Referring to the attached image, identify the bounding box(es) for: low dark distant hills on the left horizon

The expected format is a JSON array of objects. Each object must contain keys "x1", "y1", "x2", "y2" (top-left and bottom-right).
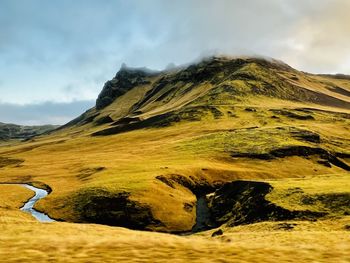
[{"x1": 0, "y1": 122, "x2": 58, "y2": 141}]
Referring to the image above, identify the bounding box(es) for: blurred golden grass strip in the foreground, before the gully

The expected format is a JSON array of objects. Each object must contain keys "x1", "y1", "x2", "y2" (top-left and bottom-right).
[{"x1": 0, "y1": 185, "x2": 350, "y2": 263}]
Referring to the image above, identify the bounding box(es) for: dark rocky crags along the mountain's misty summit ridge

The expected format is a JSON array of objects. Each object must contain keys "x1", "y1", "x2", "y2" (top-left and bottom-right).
[{"x1": 96, "y1": 57, "x2": 293, "y2": 110}]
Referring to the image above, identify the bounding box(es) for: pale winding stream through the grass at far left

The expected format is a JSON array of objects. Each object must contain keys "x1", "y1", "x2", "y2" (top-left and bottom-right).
[{"x1": 21, "y1": 184, "x2": 55, "y2": 222}]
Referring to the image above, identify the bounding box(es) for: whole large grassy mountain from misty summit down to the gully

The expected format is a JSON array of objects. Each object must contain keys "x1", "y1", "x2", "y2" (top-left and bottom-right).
[{"x1": 0, "y1": 56, "x2": 350, "y2": 233}]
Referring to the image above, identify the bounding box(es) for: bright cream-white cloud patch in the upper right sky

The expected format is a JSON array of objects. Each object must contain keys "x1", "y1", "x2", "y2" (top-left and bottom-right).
[{"x1": 280, "y1": 0, "x2": 350, "y2": 74}]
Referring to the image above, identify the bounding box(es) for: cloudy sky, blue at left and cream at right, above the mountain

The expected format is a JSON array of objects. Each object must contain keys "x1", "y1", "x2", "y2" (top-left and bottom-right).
[{"x1": 0, "y1": 0, "x2": 350, "y2": 125}]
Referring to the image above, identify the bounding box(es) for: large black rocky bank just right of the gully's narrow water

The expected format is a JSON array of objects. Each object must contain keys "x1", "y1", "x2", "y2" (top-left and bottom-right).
[{"x1": 209, "y1": 181, "x2": 325, "y2": 226}]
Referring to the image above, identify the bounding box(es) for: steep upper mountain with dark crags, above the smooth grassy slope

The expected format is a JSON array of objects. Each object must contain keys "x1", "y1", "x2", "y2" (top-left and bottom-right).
[{"x1": 64, "y1": 57, "x2": 350, "y2": 135}]
